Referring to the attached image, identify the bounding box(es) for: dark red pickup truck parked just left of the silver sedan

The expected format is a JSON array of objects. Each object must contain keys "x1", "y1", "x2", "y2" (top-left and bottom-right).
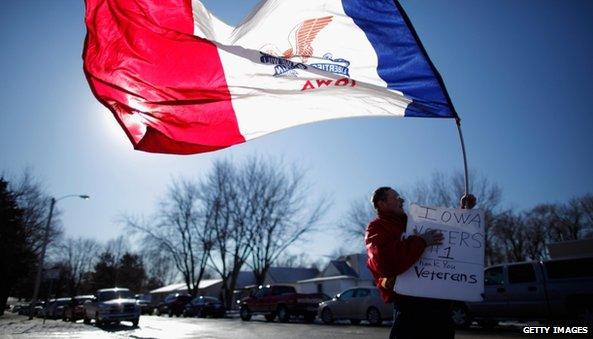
[{"x1": 239, "y1": 285, "x2": 325, "y2": 322}]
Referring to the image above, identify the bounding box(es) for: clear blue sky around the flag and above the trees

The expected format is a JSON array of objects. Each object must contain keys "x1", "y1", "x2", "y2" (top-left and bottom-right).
[{"x1": 0, "y1": 0, "x2": 593, "y2": 258}]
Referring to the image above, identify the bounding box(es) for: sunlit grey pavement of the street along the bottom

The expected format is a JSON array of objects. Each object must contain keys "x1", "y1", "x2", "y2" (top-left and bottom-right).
[{"x1": 0, "y1": 313, "x2": 582, "y2": 339}]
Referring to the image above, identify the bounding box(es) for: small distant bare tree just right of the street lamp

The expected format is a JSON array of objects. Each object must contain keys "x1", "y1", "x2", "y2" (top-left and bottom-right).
[{"x1": 59, "y1": 238, "x2": 101, "y2": 295}]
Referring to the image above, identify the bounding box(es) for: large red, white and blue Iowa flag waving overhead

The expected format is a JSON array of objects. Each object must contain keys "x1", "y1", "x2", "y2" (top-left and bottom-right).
[{"x1": 83, "y1": 0, "x2": 457, "y2": 154}]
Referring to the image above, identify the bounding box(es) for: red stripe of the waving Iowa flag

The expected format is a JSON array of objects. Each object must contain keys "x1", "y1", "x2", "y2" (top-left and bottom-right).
[{"x1": 83, "y1": 0, "x2": 245, "y2": 154}]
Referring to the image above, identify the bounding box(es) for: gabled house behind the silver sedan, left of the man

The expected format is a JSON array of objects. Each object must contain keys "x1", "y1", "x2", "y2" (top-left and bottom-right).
[{"x1": 297, "y1": 253, "x2": 373, "y2": 296}]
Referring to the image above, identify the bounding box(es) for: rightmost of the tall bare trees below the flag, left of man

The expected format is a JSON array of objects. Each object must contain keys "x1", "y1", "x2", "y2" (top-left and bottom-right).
[{"x1": 242, "y1": 158, "x2": 329, "y2": 284}]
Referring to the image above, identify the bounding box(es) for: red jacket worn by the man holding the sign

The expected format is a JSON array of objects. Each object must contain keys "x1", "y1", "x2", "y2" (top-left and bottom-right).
[{"x1": 364, "y1": 213, "x2": 426, "y2": 303}]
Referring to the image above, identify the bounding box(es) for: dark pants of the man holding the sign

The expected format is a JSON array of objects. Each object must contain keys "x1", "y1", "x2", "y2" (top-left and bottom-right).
[{"x1": 389, "y1": 297, "x2": 455, "y2": 339}]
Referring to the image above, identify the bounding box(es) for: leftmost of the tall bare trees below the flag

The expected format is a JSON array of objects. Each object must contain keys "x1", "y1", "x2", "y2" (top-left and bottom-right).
[{"x1": 125, "y1": 180, "x2": 212, "y2": 295}]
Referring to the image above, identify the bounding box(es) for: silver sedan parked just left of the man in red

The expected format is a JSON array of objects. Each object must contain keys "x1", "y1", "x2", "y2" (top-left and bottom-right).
[{"x1": 318, "y1": 286, "x2": 393, "y2": 326}]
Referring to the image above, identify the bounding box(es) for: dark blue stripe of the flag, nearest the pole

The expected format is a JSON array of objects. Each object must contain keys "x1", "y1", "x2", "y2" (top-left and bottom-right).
[{"x1": 342, "y1": 0, "x2": 456, "y2": 118}]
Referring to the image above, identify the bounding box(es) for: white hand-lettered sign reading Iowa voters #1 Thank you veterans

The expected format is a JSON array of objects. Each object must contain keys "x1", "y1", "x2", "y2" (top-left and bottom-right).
[{"x1": 395, "y1": 204, "x2": 485, "y2": 301}]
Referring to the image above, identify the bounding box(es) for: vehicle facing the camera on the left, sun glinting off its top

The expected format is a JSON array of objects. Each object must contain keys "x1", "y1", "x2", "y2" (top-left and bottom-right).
[{"x1": 83, "y1": 287, "x2": 140, "y2": 327}]
